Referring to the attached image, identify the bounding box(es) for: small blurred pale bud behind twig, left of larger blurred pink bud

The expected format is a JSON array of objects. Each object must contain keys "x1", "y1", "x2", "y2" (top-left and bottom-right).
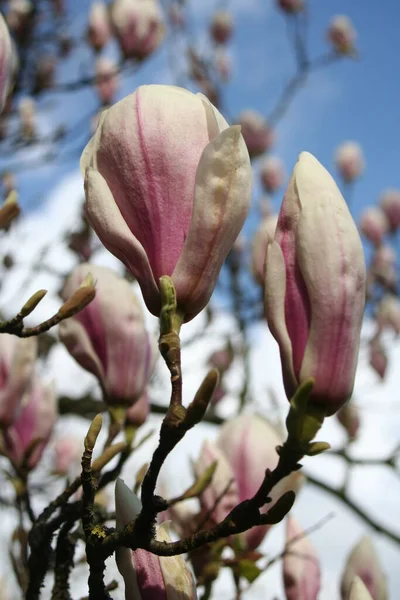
[{"x1": 194, "y1": 440, "x2": 239, "y2": 523}]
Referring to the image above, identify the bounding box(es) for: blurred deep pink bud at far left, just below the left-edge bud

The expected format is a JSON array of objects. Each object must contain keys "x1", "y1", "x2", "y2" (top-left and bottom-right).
[{"x1": 4, "y1": 375, "x2": 57, "y2": 469}]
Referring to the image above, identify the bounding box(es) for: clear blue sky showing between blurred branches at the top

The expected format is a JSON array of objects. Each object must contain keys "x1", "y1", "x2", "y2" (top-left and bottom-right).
[{"x1": 2, "y1": 0, "x2": 400, "y2": 239}]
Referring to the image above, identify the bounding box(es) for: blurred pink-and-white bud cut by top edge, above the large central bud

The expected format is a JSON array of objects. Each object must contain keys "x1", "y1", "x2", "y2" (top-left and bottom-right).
[{"x1": 110, "y1": 0, "x2": 164, "y2": 60}]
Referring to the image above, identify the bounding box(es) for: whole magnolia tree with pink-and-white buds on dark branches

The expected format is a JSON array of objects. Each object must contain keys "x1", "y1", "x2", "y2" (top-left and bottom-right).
[{"x1": 0, "y1": 0, "x2": 400, "y2": 600}]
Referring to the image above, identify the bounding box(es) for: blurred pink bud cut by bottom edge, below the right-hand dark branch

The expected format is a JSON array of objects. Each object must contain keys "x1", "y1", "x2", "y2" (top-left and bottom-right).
[{"x1": 283, "y1": 517, "x2": 321, "y2": 600}]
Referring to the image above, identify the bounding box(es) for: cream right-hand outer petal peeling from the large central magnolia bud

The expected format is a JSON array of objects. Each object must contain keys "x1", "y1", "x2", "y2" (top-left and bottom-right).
[{"x1": 172, "y1": 126, "x2": 251, "y2": 321}]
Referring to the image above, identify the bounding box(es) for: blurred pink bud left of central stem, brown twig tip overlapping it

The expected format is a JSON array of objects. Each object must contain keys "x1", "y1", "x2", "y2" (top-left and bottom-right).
[{"x1": 60, "y1": 263, "x2": 156, "y2": 406}]
